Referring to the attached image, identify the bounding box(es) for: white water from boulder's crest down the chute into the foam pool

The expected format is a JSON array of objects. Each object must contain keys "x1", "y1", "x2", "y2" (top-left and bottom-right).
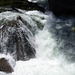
[{"x1": 0, "y1": 11, "x2": 75, "y2": 75}]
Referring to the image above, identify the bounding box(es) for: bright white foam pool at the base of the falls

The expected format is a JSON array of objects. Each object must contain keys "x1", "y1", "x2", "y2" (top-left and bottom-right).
[{"x1": 12, "y1": 59, "x2": 75, "y2": 75}]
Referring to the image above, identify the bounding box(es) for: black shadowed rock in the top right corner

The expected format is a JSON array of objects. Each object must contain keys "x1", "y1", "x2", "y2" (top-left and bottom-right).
[{"x1": 48, "y1": 0, "x2": 75, "y2": 16}]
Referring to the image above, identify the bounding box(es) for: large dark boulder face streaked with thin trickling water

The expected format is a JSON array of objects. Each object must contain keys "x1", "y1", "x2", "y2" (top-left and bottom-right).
[{"x1": 0, "y1": 16, "x2": 35, "y2": 60}]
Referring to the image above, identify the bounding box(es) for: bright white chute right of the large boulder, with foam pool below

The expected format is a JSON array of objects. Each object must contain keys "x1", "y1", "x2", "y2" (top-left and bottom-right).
[{"x1": 12, "y1": 11, "x2": 75, "y2": 75}]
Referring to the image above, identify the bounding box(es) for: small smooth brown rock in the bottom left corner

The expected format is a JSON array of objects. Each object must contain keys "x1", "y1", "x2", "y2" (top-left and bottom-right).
[{"x1": 0, "y1": 58, "x2": 14, "y2": 73}]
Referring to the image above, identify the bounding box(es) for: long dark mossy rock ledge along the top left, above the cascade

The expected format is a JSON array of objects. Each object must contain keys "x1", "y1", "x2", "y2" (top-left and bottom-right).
[{"x1": 0, "y1": 0, "x2": 45, "y2": 12}]
